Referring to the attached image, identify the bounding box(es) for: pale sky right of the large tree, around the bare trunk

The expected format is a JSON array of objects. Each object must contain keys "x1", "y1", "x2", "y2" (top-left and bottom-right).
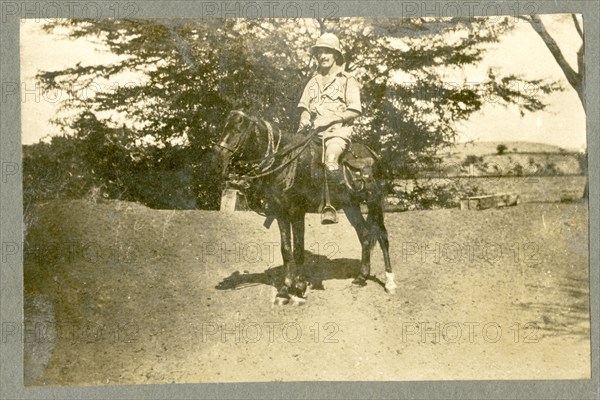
[{"x1": 459, "y1": 15, "x2": 587, "y2": 149}]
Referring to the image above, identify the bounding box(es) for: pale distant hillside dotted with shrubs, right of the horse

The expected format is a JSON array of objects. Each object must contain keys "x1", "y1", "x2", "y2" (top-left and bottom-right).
[{"x1": 438, "y1": 142, "x2": 583, "y2": 176}]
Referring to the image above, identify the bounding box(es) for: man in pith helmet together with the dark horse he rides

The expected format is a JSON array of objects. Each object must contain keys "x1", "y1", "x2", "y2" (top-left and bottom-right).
[{"x1": 216, "y1": 34, "x2": 397, "y2": 296}]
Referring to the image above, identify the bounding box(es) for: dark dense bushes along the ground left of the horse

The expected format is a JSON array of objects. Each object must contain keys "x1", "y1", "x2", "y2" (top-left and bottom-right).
[{"x1": 23, "y1": 114, "x2": 221, "y2": 209}]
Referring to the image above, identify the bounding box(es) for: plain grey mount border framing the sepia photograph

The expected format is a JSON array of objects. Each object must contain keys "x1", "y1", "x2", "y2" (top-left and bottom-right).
[{"x1": 0, "y1": 0, "x2": 600, "y2": 399}]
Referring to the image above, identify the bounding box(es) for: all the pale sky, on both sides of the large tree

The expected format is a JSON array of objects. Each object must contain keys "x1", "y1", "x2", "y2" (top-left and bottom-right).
[{"x1": 20, "y1": 15, "x2": 586, "y2": 150}]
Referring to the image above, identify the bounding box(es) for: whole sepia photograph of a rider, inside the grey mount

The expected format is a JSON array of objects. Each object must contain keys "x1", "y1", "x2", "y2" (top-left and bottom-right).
[{"x1": 18, "y1": 12, "x2": 592, "y2": 387}]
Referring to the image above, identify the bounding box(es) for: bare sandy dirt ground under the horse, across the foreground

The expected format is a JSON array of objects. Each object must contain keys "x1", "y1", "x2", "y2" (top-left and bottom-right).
[{"x1": 25, "y1": 201, "x2": 590, "y2": 385}]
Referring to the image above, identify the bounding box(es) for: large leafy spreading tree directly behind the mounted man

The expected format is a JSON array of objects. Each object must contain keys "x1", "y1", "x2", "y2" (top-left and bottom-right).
[{"x1": 39, "y1": 18, "x2": 559, "y2": 207}]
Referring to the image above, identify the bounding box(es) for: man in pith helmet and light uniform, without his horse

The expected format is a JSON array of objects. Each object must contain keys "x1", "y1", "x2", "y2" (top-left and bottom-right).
[{"x1": 298, "y1": 33, "x2": 362, "y2": 222}]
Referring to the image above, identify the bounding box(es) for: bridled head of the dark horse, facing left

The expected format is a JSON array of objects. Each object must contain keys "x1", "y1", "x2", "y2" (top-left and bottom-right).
[{"x1": 216, "y1": 110, "x2": 257, "y2": 178}]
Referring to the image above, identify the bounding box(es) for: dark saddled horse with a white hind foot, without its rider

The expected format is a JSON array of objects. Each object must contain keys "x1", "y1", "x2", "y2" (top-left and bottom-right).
[{"x1": 214, "y1": 110, "x2": 397, "y2": 304}]
